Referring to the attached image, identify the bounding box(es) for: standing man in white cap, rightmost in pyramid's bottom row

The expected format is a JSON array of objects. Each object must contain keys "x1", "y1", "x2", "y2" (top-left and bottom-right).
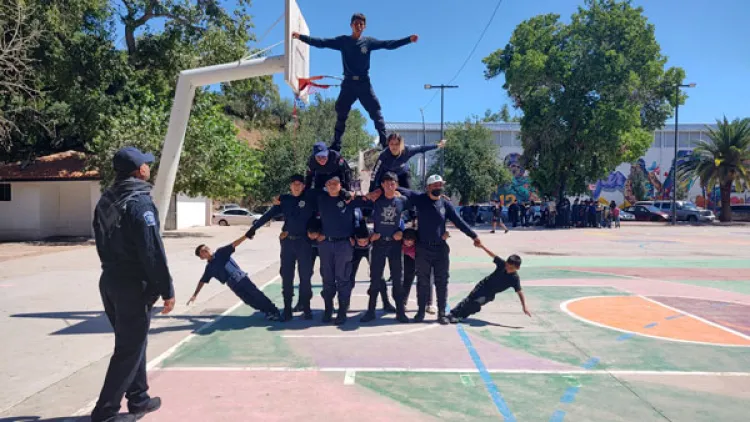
[{"x1": 369, "y1": 174, "x2": 482, "y2": 325}]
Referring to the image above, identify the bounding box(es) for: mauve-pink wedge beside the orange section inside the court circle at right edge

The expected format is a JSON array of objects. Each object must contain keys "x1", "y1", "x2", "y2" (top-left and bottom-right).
[{"x1": 651, "y1": 296, "x2": 750, "y2": 335}]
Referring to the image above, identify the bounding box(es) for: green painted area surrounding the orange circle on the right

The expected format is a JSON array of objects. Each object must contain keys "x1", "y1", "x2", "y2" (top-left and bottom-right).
[{"x1": 467, "y1": 287, "x2": 750, "y2": 372}]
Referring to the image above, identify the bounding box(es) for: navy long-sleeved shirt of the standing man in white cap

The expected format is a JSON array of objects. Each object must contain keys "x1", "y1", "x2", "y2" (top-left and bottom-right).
[{"x1": 398, "y1": 188, "x2": 477, "y2": 243}]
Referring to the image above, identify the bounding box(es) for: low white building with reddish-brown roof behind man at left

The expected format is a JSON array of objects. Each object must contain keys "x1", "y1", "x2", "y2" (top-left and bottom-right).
[{"x1": 0, "y1": 151, "x2": 211, "y2": 241}]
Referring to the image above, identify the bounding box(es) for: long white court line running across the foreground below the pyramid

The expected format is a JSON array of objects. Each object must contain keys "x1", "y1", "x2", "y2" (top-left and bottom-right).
[{"x1": 157, "y1": 366, "x2": 750, "y2": 377}]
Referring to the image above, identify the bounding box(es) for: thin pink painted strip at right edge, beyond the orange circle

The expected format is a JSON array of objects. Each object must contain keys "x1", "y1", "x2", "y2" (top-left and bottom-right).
[{"x1": 564, "y1": 267, "x2": 750, "y2": 281}]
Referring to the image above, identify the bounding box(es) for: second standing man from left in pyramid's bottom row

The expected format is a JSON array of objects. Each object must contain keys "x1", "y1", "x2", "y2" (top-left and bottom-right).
[{"x1": 317, "y1": 177, "x2": 365, "y2": 325}]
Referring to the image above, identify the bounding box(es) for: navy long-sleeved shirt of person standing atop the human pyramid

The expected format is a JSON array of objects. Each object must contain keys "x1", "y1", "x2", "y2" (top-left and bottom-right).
[{"x1": 299, "y1": 34, "x2": 411, "y2": 76}]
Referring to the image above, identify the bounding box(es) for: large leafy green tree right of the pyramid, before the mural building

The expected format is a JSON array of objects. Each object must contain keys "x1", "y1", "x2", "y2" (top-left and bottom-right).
[{"x1": 483, "y1": 0, "x2": 686, "y2": 197}]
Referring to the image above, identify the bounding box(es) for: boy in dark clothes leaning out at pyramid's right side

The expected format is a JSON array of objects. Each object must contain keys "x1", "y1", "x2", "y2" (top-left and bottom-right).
[{"x1": 448, "y1": 245, "x2": 531, "y2": 324}]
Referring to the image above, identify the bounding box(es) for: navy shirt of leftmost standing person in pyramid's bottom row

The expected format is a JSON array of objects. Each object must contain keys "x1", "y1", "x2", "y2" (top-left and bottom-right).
[{"x1": 248, "y1": 190, "x2": 318, "y2": 238}]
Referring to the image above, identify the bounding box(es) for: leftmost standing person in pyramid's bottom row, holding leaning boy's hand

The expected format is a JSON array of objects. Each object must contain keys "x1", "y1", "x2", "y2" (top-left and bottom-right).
[{"x1": 247, "y1": 174, "x2": 317, "y2": 321}]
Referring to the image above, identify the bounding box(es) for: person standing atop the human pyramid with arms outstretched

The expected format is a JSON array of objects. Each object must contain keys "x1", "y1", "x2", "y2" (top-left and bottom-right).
[{"x1": 292, "y1": 13, "x2": 418, "y2": 151}]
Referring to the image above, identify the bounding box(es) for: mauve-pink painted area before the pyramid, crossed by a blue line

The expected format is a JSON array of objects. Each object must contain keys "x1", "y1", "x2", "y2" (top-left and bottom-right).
[{"x1": 286, "y1": 324, "x2": 568, "y2": 370}]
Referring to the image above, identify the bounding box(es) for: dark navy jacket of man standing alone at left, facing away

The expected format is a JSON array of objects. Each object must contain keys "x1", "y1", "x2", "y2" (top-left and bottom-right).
[{"x1": 93, "y1": 178, "x2": 174, "y2": 301}]
